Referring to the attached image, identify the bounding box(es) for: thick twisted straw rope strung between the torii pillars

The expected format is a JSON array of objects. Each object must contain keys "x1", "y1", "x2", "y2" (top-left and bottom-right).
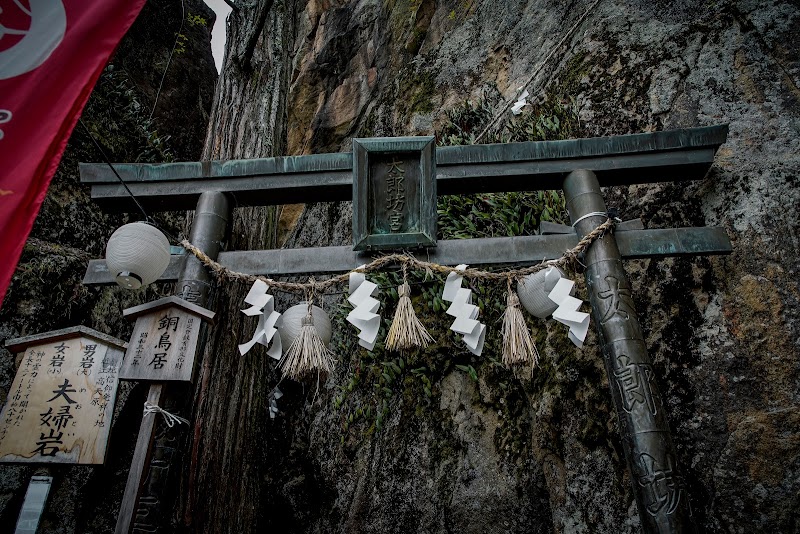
[{"x1": 181, "y1": 218, "x2": 615, "y2": 294}]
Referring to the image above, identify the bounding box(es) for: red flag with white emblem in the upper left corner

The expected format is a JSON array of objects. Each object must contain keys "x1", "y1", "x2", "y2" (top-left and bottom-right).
[{"x1": 0, "y1": 0, "x2": 145, "y2": 305}]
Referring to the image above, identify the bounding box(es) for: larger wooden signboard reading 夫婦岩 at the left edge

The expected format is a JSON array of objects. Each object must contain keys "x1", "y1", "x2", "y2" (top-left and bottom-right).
[{"x1": 0, "y1": 326, "x2": 126, "y2": 464}]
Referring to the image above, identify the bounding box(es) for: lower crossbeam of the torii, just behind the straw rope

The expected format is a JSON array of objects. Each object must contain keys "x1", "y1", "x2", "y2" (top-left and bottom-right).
[{"x1": 83, "y1": 223, "x2": 733, "y2": 285}]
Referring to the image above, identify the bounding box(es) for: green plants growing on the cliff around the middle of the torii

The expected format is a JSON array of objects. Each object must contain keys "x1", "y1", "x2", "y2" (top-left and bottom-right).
[{"x1": 332, "y1": 86, "x2": 596, "y2": 458}]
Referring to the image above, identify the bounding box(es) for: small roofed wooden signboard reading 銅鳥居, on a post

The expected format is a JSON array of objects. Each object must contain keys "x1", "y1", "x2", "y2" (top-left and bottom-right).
[{"x1": 119, "y1": 297, "x2": 214, "y2": 382}]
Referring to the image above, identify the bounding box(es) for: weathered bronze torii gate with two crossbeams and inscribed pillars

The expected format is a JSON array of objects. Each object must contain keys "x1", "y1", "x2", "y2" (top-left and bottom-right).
[{"x1": 80, "y1": 126, "x2": 731, "y2": 533}]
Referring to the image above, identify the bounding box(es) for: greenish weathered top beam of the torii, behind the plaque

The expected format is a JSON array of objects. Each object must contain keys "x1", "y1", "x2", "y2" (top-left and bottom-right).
[{"x1": 80, "y1": 125, "x2": 728, "y2": 211}]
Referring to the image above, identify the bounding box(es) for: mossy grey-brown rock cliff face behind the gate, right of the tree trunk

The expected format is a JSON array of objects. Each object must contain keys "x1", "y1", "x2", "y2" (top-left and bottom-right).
[{"x1": 202, "y1": 0, "x2": 800, "y2": 533}]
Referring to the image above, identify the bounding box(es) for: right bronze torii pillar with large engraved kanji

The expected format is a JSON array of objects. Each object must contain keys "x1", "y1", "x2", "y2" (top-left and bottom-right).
[{"x1": 564, "y1": 170, "x2": 696, "y2": 534}]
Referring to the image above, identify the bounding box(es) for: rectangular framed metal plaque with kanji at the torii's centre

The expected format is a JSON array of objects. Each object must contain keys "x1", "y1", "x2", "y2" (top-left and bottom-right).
[{"x1": 353, "y1": 137, "x2": 436, "y2": 250}]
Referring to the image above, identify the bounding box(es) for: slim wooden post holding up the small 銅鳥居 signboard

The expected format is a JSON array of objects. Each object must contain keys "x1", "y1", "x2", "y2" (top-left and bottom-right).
[{"x1": 114, "y1": 384, "x2": 163, "y2": 534}]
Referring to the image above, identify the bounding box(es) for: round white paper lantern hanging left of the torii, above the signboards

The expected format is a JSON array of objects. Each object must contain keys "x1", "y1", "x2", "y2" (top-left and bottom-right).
[{"x1": 106, "y1": 222, "x2": 169, "y2": 289}]
